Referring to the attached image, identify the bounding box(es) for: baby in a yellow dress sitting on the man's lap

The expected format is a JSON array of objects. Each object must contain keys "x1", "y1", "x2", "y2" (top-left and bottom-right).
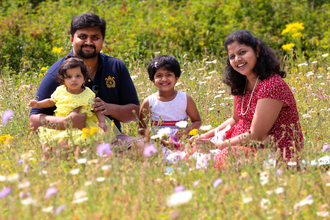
[{"x1": 28, "y1": 56, "x2": 120, "y2": 150}]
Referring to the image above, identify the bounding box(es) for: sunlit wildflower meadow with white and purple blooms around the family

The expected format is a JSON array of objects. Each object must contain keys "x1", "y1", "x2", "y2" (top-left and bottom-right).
[{"x1": 0, "y1": 1, "x2": 330, "y2": 219}]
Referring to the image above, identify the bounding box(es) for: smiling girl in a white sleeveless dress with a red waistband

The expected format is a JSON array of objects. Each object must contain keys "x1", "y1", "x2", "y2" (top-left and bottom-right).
[{"x1": 139, "y1": 55, "x2": 201, "y2": 151}]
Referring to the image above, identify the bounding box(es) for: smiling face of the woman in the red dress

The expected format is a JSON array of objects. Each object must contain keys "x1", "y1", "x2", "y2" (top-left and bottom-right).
[{"x1": 227, "y1": 41, "x2": 260, "y2": 78}]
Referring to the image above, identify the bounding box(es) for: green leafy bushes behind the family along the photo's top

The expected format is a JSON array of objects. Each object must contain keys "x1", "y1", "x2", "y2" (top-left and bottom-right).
[{"x1": 0, "y1": 0, "x2": 330, "y2": 73}]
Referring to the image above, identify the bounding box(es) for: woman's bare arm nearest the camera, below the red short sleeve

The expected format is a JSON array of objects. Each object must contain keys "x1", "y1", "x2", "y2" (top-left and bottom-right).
[{"x1": 216, "y1": 98, "x2": 285, "y2": 149}]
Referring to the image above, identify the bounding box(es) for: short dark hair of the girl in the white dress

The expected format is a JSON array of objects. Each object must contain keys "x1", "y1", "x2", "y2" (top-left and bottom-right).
[{"x1": 148, "y1": 55, "x2": 181, "y2": 81}]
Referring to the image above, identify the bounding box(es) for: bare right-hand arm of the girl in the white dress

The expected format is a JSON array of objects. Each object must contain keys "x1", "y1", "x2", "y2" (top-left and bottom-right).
[{"x1": 184, "y1": 94, "x2": 202, "y2": 135}]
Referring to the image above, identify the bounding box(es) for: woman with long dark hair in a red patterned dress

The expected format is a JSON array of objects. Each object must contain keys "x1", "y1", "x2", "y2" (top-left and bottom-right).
[{"x1": 196, "y1": 30, "x2": 304, "y2": 168}]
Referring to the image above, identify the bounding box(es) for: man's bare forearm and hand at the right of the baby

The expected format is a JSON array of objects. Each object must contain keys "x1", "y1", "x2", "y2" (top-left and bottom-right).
[{"x1": 93, "y1": 97, "x2": 140, "y2": 123}]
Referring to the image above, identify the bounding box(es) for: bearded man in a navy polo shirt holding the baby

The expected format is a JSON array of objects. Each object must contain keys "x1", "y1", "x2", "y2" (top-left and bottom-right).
[{"x1": 30, "y1": 13, "x2": 140, "y2": 150}]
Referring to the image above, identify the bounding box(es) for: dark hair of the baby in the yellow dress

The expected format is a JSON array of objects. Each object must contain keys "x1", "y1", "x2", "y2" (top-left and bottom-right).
[{"x1": 56, "y1": 55, "x2": 89, "y2": 89}]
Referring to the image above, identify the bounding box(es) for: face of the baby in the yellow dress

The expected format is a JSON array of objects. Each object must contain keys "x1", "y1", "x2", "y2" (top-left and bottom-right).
[{"x1": 64, "y1": 67, "x2": 85, "y2": 94}]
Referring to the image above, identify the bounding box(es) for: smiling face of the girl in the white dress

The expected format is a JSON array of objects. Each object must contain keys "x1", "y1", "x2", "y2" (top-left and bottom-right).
[{"x1": 152, "y1": 67, "x2": 179, "y2": 92}]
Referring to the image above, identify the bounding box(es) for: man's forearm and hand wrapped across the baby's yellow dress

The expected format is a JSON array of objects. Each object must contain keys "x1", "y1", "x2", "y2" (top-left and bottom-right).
[{"x1": 30, "y1": 107, "x2": 86, "y2": 131}]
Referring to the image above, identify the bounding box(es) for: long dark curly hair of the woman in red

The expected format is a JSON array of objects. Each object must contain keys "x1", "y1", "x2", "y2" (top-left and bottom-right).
[{"x1": 223, "y1": 30, "x2": 286, "y2": 95}]
